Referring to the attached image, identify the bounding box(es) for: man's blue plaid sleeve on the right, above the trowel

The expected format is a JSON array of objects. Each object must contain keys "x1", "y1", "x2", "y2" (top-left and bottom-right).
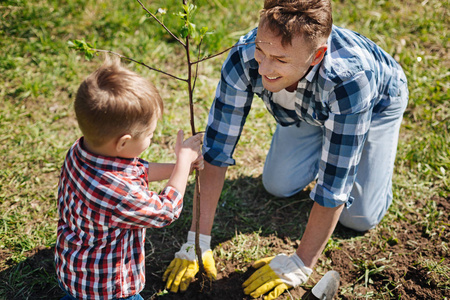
[{"x1": 310, "y1": 71, "x2": 375, "y2": 207}]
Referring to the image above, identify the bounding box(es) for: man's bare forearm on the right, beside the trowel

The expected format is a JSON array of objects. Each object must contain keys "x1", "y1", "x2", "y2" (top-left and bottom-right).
[{"x1": 297, "y1": 202, "x2": 344, "y2": 269}]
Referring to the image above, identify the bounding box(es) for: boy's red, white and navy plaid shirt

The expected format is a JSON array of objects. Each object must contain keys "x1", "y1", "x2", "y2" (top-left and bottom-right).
[{"x1": 55, "y1": 138, "x2": 183, "y2": 299}]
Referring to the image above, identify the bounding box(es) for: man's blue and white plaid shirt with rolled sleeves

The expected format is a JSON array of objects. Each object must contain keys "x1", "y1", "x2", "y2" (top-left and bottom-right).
[{"x1": 204, "y1": 26, "x2": 407, "y2": 207}]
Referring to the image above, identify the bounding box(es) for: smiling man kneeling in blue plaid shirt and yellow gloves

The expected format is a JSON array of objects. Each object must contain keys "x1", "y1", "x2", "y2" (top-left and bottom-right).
[{"x1": 163, "y1": 0, "x2": 408, "y2": 299}]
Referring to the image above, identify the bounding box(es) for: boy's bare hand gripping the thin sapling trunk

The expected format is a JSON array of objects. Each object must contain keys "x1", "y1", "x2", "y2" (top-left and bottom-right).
[{"x1": 175, "y1": 130, "x2": 203, "y2": 166}]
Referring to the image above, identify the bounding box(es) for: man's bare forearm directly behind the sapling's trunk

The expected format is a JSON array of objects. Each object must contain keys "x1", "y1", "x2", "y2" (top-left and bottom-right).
[{"x1": 191, "y1": 161, "x2": 227, "y2": 236}]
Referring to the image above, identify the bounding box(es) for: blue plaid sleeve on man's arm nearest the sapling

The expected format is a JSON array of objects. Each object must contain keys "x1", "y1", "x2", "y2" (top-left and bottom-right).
[{"x1": 203, "y1": 47, "x2": 253, "y2": 167}]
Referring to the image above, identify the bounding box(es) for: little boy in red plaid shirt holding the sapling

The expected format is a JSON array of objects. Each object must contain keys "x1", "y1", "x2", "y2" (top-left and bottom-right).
[{"x1": 55, "y1": 57, "x2": 203, "y2": 300}]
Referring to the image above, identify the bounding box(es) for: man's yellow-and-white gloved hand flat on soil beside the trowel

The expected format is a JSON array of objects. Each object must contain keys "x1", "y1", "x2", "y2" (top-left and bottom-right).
[{"x1": 242, "y1": 253, "x2": 312, "y2": 300}]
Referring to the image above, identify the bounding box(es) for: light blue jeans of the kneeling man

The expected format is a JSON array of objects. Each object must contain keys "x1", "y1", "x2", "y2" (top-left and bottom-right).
[{"x1": 263, "y1": 82, "x2": 408, "y2": 231}]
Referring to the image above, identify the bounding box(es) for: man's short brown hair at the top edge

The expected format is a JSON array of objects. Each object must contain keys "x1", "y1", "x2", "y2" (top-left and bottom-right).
[{"x1": 260, "y1": 0, "x2": 333, "y2": 46}]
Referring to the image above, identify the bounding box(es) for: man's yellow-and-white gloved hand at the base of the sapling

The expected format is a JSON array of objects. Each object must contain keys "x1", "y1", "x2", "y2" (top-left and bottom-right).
[{"x1": 163, "y1": 231, "x2": 217, "y2": 293}]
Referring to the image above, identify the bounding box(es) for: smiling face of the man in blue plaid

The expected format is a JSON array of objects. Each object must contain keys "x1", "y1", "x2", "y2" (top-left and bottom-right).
[{"x1": 255, "y1": 24, "x2": 326, "y2": 92}]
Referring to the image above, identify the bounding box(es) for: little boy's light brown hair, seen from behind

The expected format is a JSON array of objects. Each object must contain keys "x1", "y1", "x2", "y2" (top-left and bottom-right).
[{"x1": 74, "y1": 56, "x2": 163, "y2": 146}]
